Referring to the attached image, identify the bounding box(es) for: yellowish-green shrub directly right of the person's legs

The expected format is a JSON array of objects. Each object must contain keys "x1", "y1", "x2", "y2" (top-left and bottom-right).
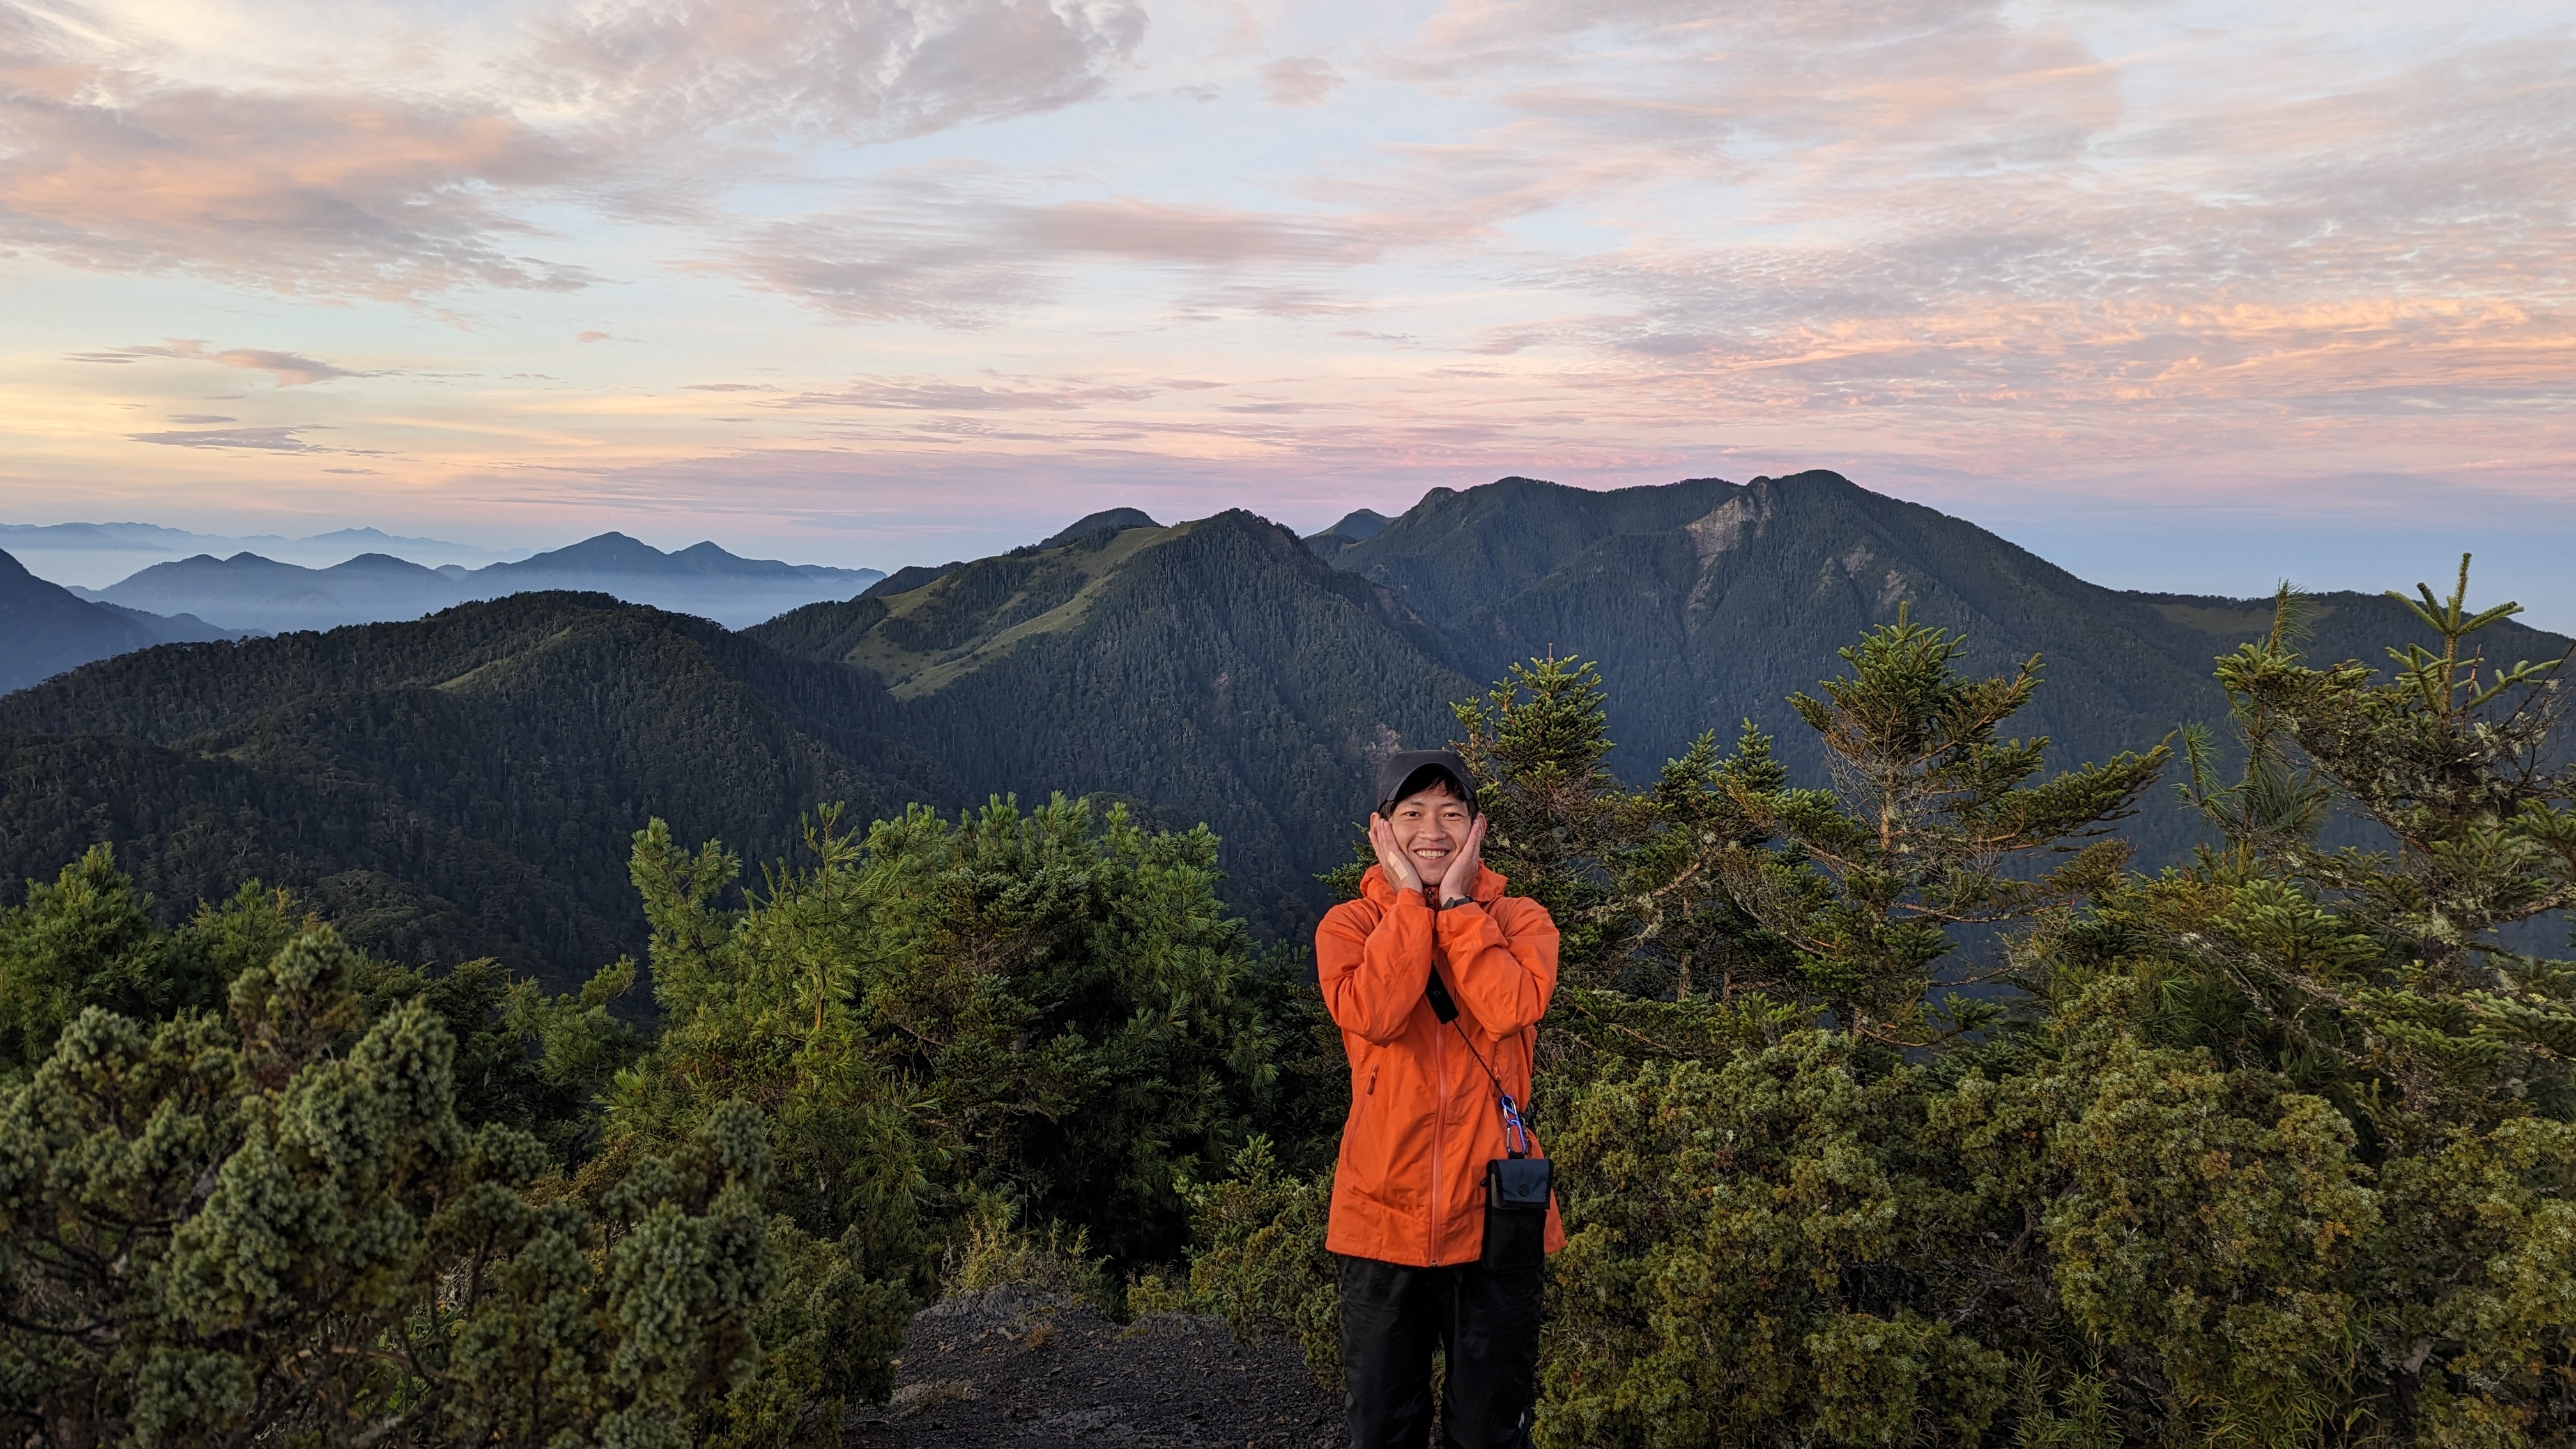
[{"x1": 1538, "y1": 1031, "x2": 2009, "y2": 1446}]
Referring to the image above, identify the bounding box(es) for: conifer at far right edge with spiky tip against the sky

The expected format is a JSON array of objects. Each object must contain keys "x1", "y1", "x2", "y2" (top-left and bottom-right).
[{"x1": 2218, "y1": 555, "x2": 2576, "y2": 1114}]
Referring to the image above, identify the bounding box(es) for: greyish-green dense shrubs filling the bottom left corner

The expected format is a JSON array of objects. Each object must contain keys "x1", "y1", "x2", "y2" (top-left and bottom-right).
[{"x1": 0, "y1": 928, "x2": 901, "y2": 1444}]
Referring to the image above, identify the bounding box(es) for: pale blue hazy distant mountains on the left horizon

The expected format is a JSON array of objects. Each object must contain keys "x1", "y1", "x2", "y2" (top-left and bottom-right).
[{"x1": 57, "y1": 521, "x2": 886, "y2": 632}]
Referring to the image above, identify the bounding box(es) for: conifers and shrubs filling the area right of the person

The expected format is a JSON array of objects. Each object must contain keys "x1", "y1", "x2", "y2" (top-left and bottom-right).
[{"x1": 1190, "y1": 565, "x2": 2576, "y2": 1449}]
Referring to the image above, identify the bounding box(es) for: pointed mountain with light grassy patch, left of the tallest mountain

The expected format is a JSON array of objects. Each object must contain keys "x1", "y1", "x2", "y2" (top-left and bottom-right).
[{"x1": 752, "y1": 510, "x2": 1471, "y2": 933}]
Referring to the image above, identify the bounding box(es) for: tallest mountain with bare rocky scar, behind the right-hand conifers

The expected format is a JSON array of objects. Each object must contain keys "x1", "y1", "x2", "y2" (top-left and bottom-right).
[{"x1": 1332, "y1": 472, "x2": 2568, "y2": 856}]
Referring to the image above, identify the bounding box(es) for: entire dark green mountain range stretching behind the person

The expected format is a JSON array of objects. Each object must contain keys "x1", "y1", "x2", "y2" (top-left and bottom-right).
[{"x1": 0, "y1": 472, "x2": 2568, "y2": 980}]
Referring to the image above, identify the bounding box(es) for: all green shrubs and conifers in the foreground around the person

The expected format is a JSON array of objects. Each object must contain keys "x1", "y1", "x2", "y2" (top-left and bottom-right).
[{"x1": 0, "y1": 559, "x2": 2576, "y2": 1449}]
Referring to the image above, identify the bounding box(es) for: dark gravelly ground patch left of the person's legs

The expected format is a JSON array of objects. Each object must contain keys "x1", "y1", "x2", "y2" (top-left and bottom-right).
[{"x1": 845, "y1": 1287, "x2": 1347, "y2": 1449}]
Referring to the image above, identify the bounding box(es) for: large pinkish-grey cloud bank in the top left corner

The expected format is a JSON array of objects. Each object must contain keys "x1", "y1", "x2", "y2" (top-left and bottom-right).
[{"x1": 0, "y1": 0, "x2": 1144, "y2": 299}]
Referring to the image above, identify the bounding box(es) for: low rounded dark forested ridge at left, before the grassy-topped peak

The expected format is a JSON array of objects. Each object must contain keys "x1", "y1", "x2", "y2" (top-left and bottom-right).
[{"x1": 0, "y1": 593, "x2": 956, "y2": 972}]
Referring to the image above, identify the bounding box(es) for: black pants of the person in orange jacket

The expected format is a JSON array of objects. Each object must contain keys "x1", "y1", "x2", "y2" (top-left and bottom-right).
[{"x1": 1342, "y1": 1258, "x2": 1543, "y2": 1449}]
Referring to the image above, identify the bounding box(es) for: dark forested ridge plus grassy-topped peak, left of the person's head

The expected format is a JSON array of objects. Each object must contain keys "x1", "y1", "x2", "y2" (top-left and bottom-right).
[{"x1": 0, "y1": 513, "x2": 1473, "y2": 977}]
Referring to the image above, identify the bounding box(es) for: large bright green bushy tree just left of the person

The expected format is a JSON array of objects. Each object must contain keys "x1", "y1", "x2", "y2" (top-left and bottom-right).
[{"x1": 608, "y1": 797, "x2": 1280, "y2": 1268}]
